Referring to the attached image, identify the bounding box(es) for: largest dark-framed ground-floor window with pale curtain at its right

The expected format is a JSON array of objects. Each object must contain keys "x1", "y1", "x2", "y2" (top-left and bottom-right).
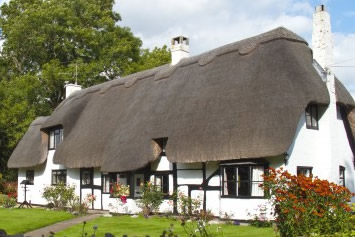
[{"x1": 222, "y1": 165, "x2": 265, "y2": 197}]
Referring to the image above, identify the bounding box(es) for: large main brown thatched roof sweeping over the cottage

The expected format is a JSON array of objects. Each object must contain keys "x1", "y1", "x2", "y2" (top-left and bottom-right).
[{"x1": 7, "y1": 28, "x2": 354, "y2": 171}]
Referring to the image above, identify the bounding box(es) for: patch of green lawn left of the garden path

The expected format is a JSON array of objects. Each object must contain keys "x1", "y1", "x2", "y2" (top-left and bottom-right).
[{"x1": 0, "y1": 208, "x2": 75, "y2": 235}]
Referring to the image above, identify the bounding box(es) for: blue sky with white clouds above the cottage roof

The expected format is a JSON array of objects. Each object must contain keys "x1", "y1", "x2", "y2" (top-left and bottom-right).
[{"x1": 0, "y1": 0, "x2": 355, "y2": 98}]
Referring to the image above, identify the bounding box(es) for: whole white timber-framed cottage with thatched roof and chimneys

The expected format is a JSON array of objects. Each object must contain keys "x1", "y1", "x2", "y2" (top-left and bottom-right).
[{"x1": 8, "y1": 6, "x2": 355, "y2": 219}]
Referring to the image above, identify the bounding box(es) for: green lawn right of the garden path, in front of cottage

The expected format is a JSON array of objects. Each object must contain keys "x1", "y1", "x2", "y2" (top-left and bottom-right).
[{"x1": 55, "y1": 216, "x2": 275, "y2": 237}]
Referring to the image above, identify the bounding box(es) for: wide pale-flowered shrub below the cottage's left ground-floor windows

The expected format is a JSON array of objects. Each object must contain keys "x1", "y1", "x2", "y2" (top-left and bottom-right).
[{"x1": 42, "y1": 183, "x2": 76, "y2": 209}]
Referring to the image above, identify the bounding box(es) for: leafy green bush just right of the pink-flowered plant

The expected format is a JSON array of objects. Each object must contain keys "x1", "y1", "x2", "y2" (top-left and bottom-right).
[{"x1": 138, "y1": 182, "x2": 164, "y2": 214}]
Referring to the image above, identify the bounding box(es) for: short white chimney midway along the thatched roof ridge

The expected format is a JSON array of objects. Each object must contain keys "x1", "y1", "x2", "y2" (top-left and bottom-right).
[{"x1": 171, "y1": 36, "x2": 190, "y2": 65}]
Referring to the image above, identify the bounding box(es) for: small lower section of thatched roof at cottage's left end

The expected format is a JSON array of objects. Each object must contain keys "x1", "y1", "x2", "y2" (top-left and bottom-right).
[{"x1": 7, "y1": 117, "x2": 48, "y2": 168}]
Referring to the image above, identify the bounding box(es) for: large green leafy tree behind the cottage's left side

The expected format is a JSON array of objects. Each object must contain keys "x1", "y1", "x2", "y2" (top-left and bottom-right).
[{"x1": 0, "y1": 0, "x2": 170, "y2": 178}]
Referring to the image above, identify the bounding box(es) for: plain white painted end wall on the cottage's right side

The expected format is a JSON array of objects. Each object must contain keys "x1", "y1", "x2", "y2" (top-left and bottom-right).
[{"x1": 285, "y1": 71, "x2": 355, "y2": 202}]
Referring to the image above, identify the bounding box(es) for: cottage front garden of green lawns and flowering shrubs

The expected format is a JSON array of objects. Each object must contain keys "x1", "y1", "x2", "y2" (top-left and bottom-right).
[{"x1": 0, "y1": 169, "x2": 355, "y2": 237}]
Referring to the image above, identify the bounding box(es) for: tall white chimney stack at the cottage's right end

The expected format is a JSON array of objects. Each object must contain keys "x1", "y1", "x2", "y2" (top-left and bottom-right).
[{"x1": 312, "y1": 5, "x2": 334, "y2": 69}]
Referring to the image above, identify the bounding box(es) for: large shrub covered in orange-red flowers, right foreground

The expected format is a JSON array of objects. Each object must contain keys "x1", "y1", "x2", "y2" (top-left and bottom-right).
[{"x1": 264, "y1": 169, "x2": 352, "y2": 236}]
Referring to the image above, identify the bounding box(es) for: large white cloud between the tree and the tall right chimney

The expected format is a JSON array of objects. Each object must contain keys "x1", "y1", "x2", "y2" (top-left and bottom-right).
[{"x1": 115, "y1": 0, "x2": 312, "y2": 54}]
